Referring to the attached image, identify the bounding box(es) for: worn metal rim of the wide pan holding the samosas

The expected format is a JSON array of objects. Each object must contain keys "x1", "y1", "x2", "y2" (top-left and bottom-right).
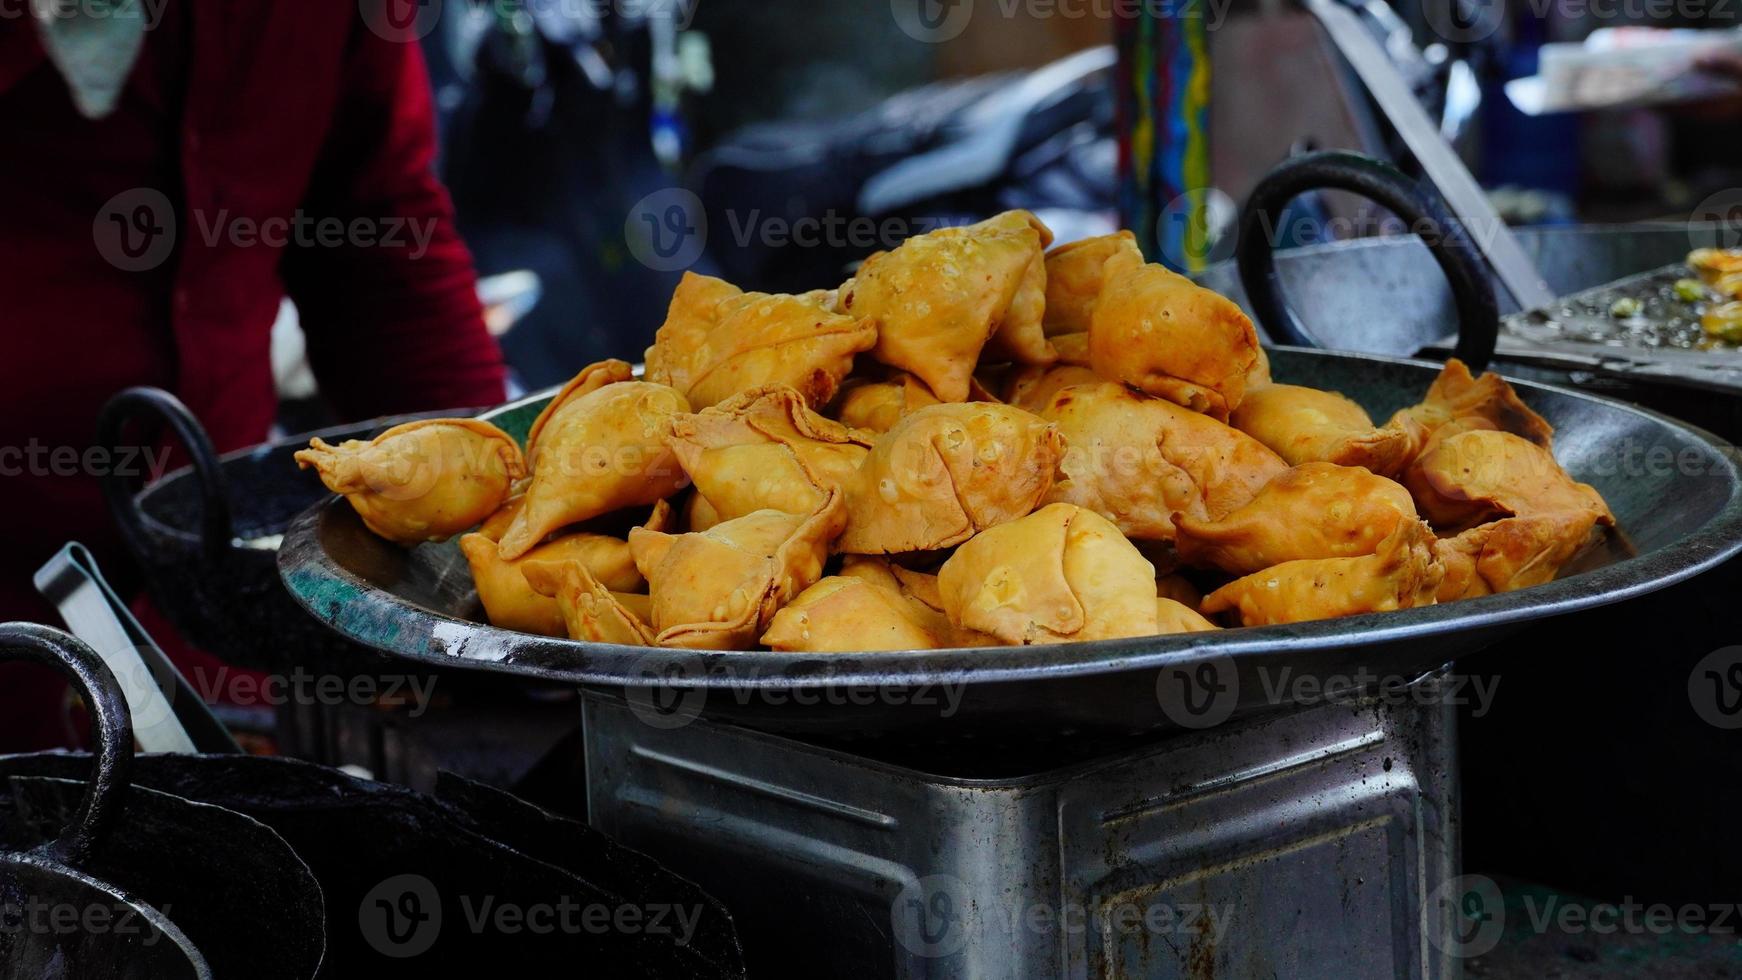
[{"x1": 279, "y1": 345, "x2": 1742, "y2": 689}]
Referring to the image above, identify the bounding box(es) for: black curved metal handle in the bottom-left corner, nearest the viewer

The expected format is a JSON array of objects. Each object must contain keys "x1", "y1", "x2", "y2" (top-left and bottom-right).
[{"x1": 0, "y1": 623, "x2": 132, "y2": 867}]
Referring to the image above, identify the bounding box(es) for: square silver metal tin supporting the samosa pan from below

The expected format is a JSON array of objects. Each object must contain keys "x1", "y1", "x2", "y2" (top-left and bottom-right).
[{"x1": 585, "y1": 681, "x2": 1460, "y2": 980}]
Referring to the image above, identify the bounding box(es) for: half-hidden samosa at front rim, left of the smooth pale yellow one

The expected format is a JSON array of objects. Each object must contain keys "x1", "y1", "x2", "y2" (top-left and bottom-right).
[{"x1": 761, "y1": 555, "x2": 998, "y2": 653}]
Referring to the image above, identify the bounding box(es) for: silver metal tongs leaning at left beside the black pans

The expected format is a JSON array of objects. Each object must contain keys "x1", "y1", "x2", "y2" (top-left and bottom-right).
[{"x1": 35, "y1": 541, "x2": 242, "y2": 754}]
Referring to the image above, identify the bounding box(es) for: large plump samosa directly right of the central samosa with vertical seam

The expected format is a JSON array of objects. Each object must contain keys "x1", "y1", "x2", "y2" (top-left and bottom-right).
[{"x1": 1040, "y1": 381, "x2": 1287, "y2": 541}]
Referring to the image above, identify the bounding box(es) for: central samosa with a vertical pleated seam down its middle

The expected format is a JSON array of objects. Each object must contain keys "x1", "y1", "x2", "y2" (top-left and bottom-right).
[{"x1": 836, "y1": 402, "x2": 1064, "y2": 555}]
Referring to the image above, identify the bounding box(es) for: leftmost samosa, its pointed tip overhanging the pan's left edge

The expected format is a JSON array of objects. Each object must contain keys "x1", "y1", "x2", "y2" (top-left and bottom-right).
[{"x1": 296, "y1": 418, "x2": 526, "y2": 547}]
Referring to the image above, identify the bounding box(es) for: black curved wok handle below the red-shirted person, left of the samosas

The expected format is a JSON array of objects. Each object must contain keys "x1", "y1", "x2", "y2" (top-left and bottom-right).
[{"x1": 98, "y1": 388, "x2": 235, "y2": 559}]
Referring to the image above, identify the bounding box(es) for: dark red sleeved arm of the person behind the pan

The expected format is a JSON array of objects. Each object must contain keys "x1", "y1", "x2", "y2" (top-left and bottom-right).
[{"x1": 282, "y1": 19, "x2": 503, "y2": 420}]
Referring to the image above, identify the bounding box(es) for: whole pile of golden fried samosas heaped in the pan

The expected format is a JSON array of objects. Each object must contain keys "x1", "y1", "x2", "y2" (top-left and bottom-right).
[{"x1": 298, "y1": 211, "x2": 1615, "y2": 651}]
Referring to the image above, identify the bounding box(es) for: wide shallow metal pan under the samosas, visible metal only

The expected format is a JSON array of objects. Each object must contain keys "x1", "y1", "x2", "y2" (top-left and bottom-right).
[{"x1": 279, "y1": 348, "x2": 1742, "y2": 736}]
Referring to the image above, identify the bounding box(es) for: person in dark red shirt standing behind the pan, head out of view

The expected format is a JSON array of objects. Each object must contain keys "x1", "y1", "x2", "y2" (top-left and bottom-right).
[{"x1": 0, "y1": 0, "x2": 503, "y2": 752}]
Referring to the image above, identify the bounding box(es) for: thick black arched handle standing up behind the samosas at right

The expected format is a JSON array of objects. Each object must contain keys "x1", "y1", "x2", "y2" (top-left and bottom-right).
[{"x1": 1235, "y1": 150, "x2": 1500, "y2": 371}]
